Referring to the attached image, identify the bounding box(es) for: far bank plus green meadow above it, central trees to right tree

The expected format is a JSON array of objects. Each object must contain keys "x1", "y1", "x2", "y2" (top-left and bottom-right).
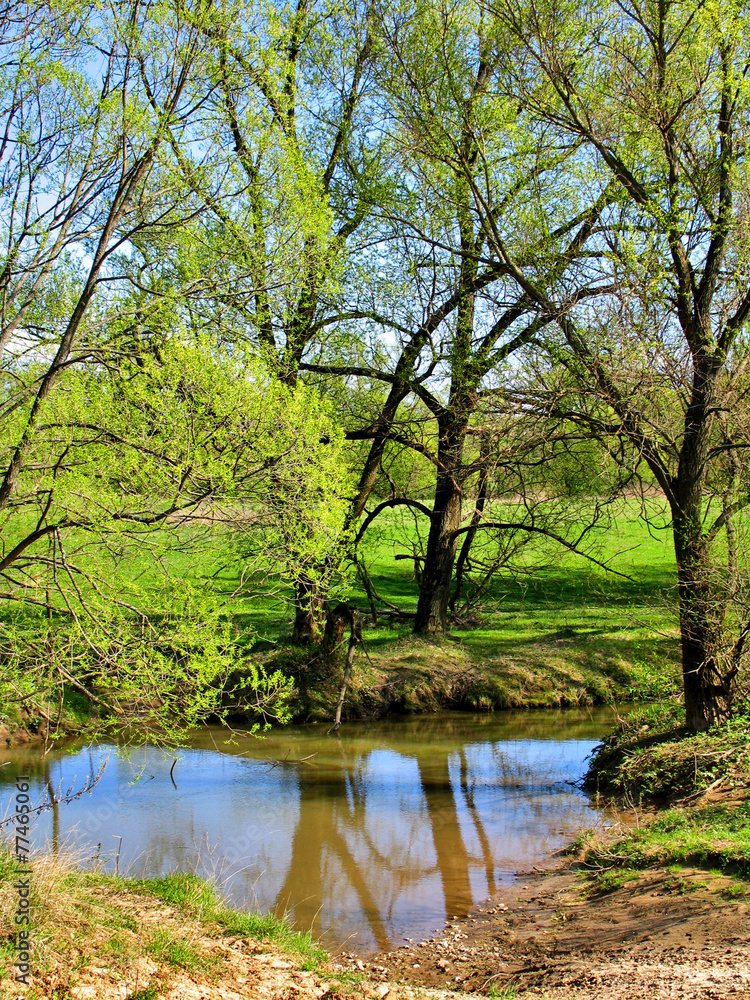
[{"x1": 260, "y1": 502, "x2": 681, "y2": 718}]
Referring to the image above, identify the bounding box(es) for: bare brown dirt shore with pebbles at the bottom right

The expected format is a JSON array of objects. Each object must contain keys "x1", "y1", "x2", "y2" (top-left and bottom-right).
[{"x1": 344, "y1": 860, "x2": 750, "y2": 1000}]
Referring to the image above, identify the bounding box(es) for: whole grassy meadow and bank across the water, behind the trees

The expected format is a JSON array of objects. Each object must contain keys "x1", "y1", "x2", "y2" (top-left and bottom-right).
[{"x1": 4, "y1": 499, "x2": 680, "y2": 728}]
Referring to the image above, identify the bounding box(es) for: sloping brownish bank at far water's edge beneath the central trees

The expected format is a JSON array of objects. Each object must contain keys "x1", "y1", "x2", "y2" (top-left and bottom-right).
[{"x1": 278, "y1": 629, "x2": 679, "y2": 722}]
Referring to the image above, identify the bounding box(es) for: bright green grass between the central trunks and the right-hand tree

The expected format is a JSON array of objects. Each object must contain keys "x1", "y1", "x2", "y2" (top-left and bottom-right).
[{"x1": 364, "y1": 492, "x2": 676, "y2": 648}]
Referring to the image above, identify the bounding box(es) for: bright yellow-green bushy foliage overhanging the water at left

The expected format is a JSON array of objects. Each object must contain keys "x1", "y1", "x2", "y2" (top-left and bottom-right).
[{"x1": 0, "y1": 339, "x2": 348, "y2": 742}]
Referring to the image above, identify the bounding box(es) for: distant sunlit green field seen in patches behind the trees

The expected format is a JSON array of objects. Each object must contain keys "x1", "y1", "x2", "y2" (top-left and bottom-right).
[{"x1": 145, "y1": 501, "x2": 676, "y2": 676}]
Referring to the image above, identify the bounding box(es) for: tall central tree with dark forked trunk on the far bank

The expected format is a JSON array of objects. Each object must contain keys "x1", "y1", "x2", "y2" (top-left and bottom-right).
[{"x1": 301, "y1": 2, "x2": 607, "y2": 635}]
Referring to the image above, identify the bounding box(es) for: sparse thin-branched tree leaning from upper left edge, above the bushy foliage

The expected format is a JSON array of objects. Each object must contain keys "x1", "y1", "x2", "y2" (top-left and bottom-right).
[{"x1": 0, "y1": 3, "x2": 209, "y2": 570}]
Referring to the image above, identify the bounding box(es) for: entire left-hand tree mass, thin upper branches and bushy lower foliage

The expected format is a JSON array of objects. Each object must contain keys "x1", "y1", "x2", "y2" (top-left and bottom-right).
[{"x1": 0, "y1": 3, "x2": 352, "y2": 736}]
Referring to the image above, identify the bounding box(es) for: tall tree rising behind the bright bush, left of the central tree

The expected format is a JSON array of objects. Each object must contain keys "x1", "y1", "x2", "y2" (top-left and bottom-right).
[{"x1": 159, "y1": 0, "x2": 382, "y2": 644}]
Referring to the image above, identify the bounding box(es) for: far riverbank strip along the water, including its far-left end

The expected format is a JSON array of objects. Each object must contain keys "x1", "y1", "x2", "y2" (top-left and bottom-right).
[{"x1": 0, "y1": 626, "x2": 681, "y2": 747}]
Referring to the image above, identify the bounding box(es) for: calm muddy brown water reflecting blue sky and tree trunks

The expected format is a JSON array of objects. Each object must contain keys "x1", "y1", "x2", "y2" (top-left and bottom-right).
[{"x1": 0, "y1": 709, "x2": 614, "y2": 951}]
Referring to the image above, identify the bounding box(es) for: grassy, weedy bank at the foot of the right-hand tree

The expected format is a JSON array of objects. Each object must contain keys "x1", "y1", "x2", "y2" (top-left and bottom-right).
[{"x1": 576, "y1": 707, "x2": 750, "y2": 896}]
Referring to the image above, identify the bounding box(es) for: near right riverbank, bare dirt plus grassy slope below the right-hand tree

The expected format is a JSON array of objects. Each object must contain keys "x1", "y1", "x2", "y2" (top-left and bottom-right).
[{"x1": 372, "y1": 708, "x2": 750, "y2": 1000}]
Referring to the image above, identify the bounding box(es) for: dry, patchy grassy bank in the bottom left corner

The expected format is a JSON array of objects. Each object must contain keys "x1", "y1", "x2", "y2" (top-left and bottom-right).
[{"x1": 0, "y1": 848, "x2": 326, "y2": 1000}]
